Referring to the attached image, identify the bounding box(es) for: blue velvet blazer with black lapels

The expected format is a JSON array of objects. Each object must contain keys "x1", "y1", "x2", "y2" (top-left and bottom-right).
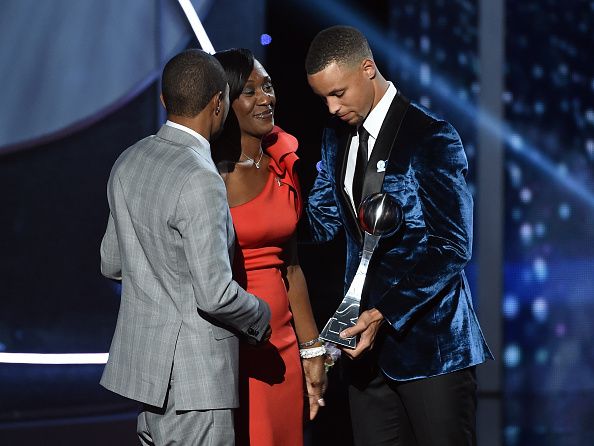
[{"x1": 307, "y1": 94, "x2": 492, "y2": 381}]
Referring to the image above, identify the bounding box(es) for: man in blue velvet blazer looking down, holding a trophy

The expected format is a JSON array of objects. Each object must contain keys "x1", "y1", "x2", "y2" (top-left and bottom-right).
[{"x1": 305, "y1": 26, "x2": 492, "y2": 446}]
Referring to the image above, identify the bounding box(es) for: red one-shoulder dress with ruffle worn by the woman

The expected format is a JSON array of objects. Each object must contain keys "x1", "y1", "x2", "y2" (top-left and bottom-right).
[{"x1": 231, "y1": 127, "x2": 304, "y2": 446}]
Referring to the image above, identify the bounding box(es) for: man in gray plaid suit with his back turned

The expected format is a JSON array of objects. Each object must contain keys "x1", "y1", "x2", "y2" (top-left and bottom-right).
[{"x1": 101, "y1": 50, "x2": 270, "y2": 445}]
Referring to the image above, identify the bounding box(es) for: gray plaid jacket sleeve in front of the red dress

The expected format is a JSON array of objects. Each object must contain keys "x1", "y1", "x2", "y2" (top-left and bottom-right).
[{"x1": 176, "y1": 170, "x2": 270, "y2": 340}]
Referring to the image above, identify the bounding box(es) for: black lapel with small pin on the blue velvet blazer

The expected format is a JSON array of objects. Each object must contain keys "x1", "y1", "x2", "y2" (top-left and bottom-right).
[{"x1": 361, "y1": 92, "x2": 410, "y2": 198}]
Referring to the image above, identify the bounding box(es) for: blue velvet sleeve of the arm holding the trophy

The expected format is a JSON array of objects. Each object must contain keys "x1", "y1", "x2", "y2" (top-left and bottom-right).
[{"x1": 376, "y1": 121, "x2": 473, "y2": 331}]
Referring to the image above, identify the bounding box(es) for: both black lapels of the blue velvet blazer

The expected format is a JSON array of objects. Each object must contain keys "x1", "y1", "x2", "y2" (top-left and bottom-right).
[{"x1": 335, "y1": 92, "x2": 410, "y2": 244}]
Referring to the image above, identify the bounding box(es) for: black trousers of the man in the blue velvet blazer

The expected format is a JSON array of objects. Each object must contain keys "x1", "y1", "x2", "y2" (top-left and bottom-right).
[{"x1": 349, "y1": 361, "x2": 477, "y2": 446}]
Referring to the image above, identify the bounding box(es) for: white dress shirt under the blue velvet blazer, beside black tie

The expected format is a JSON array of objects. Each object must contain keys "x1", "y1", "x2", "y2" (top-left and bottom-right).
[{"x1": 344, "y1": 82, "x2": 396, "y2": 214}]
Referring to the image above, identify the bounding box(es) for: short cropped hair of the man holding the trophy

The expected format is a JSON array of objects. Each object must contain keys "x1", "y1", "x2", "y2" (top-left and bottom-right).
[{"x1": 305, "y1": 25, "x2": 373, "y2": 75}]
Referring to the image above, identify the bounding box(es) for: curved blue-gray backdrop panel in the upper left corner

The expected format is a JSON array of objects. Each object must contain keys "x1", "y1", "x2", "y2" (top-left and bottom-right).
[{"x1": 0, "y1": 0, "x2": 212, "y2": 151}]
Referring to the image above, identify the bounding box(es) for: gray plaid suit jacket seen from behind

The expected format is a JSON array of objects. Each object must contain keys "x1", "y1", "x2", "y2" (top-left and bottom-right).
[{"x1": 101, "y1": 125, "x2": 270, "y2": 410}]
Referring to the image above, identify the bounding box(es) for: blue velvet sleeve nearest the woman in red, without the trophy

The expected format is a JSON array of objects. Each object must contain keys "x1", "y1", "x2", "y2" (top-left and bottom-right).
[{"x1": 307, "y1": 125, "x2": 342, "y2": 243}]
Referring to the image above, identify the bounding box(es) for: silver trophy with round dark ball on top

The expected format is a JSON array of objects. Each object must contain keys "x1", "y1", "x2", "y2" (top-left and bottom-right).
[{"x1": 320, "y1": 193, "x2": 402, "y2": 348}]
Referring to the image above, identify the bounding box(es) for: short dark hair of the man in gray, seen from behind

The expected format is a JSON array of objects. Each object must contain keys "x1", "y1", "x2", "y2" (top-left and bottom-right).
[{"x1": 161, "y1": 49, "x2": 226, "y2": 118}]
